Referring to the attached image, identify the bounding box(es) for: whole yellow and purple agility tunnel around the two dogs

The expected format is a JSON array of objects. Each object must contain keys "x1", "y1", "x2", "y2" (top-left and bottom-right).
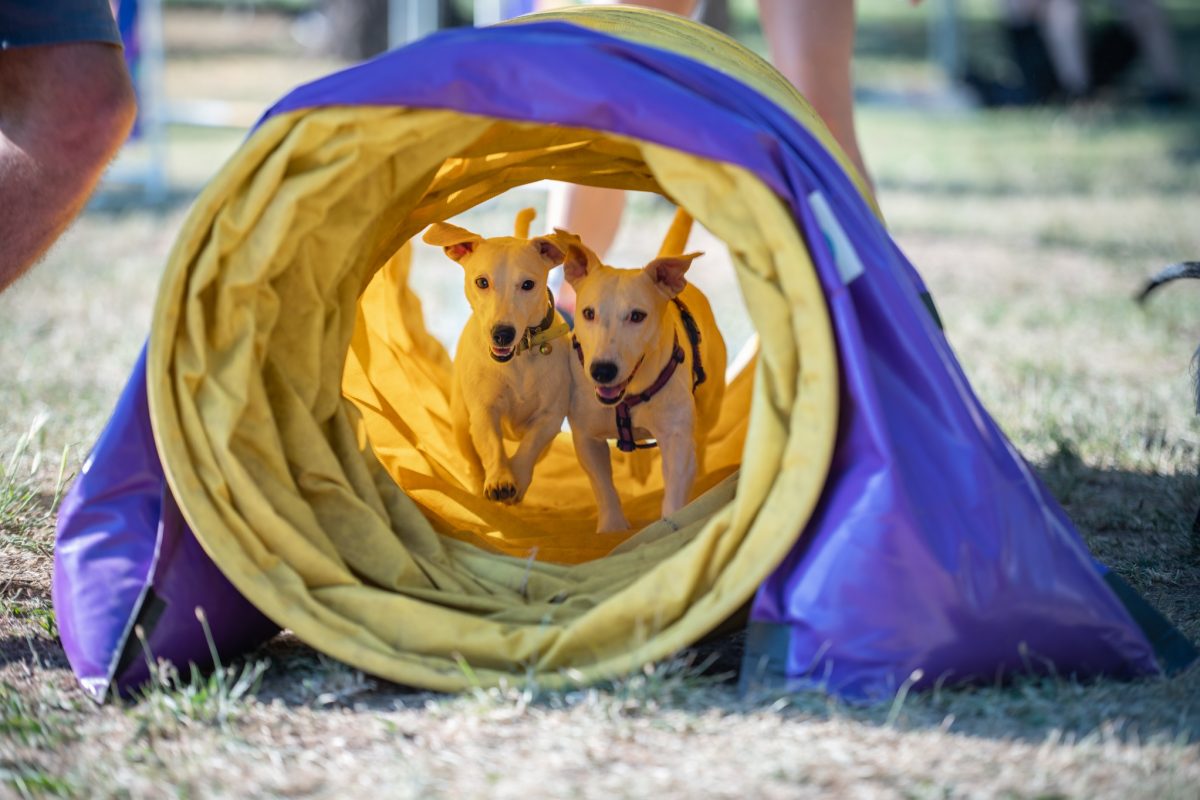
[{"x1": 54, "y1": 7, "x2": 1194, "y2": 699}]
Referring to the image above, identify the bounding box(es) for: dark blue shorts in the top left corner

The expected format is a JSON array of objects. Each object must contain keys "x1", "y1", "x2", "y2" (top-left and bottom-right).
[{"x1": 0, "y1": 0, "x2": 121, "y2": 50}]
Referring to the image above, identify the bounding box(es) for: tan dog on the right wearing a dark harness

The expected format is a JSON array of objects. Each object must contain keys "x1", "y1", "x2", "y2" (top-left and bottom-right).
[{"x1": 556, "y1": 230, "x2": 726, "y2": 533}]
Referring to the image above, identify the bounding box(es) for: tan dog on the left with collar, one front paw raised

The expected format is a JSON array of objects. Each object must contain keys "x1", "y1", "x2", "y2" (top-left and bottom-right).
[{"x1": 422, "y1": 209, "x2": 570, "y2": 504}]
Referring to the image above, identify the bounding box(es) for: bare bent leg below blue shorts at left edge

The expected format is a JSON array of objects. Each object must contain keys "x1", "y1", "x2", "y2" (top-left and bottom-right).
[{"x1": 0, "y1": 42, "x2": 136, "y2": 290}]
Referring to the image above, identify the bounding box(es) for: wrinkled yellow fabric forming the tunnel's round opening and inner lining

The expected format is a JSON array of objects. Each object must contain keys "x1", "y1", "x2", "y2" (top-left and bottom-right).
[{"x1": 148, "y1": 10, "x2": 838, "y2": 690}]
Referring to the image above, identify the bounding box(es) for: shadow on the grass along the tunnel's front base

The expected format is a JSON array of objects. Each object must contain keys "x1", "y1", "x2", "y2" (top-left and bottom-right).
[{"x1": 238, "y1": 632, "x2": 1200, "y2": 745}]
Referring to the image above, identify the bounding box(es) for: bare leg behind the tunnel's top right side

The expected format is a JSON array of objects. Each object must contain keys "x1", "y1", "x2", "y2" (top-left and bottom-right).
[{"x1": 758, "y1": 0, "x2": 871, "y2": 193}]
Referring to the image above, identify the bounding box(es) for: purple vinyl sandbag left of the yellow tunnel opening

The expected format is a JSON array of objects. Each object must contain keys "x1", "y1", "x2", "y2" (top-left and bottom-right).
[{"x1": 52, "y1": 349, "x2": 278, "y2": 700}]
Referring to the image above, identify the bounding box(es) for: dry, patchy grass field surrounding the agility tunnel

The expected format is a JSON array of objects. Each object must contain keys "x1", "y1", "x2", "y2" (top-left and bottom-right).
[{"x1": 0, "y1": 2, "x2": 1200, "y2": 799}]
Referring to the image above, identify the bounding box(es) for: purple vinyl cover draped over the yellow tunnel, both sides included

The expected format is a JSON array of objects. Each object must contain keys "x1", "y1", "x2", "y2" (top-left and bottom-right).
[{"x1": 54, "y1": 23, "x2": 1158, "y2": 698}]
